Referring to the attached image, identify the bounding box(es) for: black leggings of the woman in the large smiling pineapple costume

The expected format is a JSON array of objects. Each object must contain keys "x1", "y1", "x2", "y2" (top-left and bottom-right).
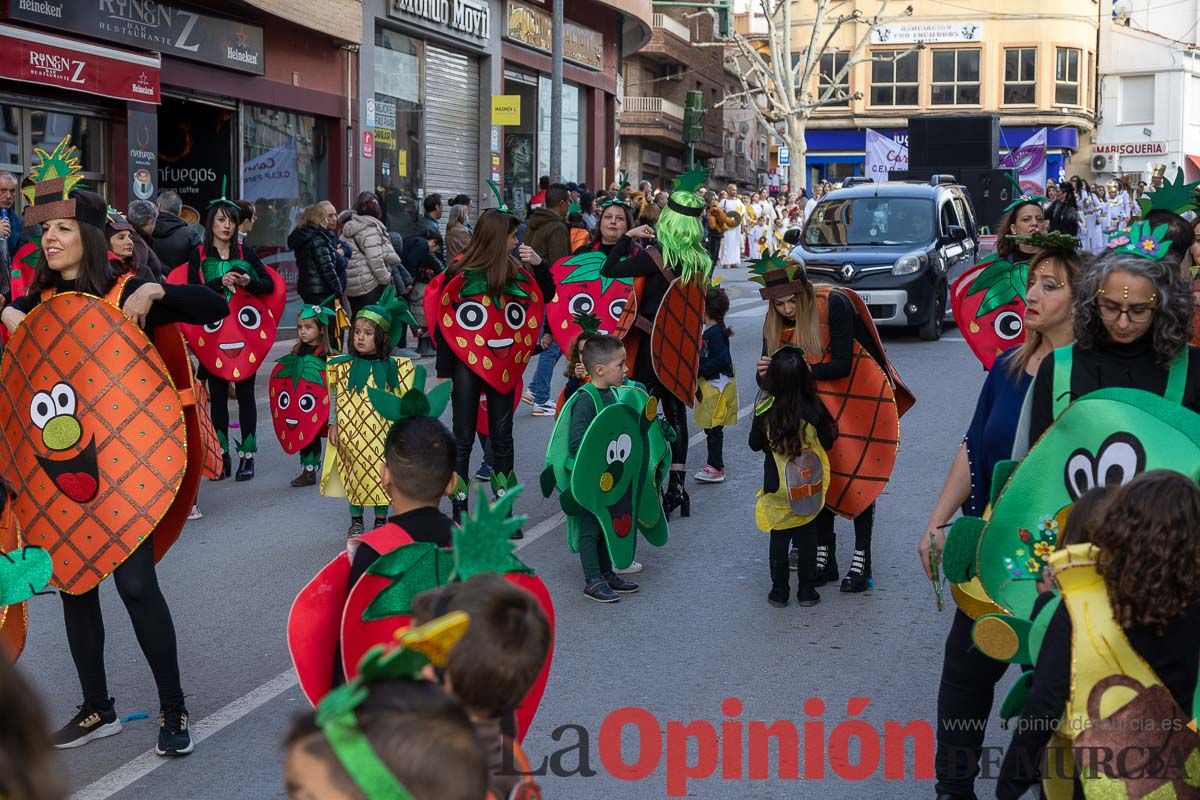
[{"x1": 59, "y1": 540, "x2": 184, "y2": 708}]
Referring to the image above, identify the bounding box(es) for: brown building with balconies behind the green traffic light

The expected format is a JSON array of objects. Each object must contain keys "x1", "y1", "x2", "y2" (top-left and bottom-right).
[{"x1": 619, "y1": 8, "x2": 725, "y2": 188}]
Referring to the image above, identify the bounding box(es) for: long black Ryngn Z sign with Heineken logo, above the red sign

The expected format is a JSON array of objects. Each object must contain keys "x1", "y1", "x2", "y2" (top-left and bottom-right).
[{"x1": 8, "y1": 0, "x2": 263, "y2": 76}]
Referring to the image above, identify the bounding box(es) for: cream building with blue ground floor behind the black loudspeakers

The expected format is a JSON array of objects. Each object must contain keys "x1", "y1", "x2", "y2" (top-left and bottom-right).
[{"x1": 736, "y1": 0, "x2": 1109, "y2": 186}]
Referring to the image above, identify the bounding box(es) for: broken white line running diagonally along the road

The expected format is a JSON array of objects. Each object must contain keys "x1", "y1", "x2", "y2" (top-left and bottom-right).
[{"x1": 71, "y1": 395, "x2": 754, "y2": 800}]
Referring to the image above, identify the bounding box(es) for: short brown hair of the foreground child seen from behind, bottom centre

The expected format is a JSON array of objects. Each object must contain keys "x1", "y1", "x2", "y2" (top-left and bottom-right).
[{"x1": 413, "y1": 573, "x2": 550, "y2": 717}]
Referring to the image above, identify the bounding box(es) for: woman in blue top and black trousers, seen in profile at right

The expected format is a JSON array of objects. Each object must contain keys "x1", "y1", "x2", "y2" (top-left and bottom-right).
[{"x1": 917, "y1": 233, "x2": 1084, "y2": 800}]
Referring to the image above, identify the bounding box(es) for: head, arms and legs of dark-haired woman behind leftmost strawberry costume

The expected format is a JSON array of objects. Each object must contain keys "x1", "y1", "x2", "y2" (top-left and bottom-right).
[{"x1": 187, "y1": 197, "x2": 276, "y2": 481}]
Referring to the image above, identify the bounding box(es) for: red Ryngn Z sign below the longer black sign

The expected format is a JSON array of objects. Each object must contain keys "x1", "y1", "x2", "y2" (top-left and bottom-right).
[{"x1": 0, "y1": 25, "x2": 161, "y2": 103}]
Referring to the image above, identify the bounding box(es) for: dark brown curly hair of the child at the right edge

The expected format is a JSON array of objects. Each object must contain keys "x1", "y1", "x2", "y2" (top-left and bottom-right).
[{"x1": 1092, "y1": 470, "x2": 1200, "y2": 634}]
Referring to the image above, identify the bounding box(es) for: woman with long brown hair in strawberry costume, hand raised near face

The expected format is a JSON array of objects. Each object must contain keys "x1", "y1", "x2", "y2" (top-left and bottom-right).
[{"x1": 425, "y1": 199, "x2": 554, "y2": 522}]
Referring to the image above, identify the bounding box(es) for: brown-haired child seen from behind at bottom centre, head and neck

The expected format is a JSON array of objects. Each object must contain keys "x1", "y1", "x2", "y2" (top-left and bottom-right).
[{"x1": 413, "y1": 573, "x2": 552, "y2": 798}]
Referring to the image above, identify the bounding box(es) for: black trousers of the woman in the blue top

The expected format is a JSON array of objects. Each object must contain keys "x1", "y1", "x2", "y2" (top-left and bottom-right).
[{"x1": 934, "y1": 609, "x2": 1008, "y2": 794}]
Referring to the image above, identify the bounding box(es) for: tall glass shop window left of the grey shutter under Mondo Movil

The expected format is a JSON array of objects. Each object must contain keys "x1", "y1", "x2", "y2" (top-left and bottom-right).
[{"x1": 373, "y1": 28, "x2": 425, "y2": 236}]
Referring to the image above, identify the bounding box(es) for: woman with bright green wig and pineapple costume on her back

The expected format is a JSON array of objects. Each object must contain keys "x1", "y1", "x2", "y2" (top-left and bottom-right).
[{"x1": 600, "y1": 168, "x2": 713, "y2": 517}]
